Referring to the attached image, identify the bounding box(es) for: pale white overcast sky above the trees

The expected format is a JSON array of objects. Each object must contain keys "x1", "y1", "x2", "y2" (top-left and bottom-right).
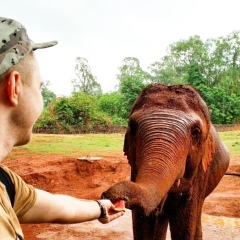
[{"x1": 0, "y1": 0, "x2": 240, "y2": 95}]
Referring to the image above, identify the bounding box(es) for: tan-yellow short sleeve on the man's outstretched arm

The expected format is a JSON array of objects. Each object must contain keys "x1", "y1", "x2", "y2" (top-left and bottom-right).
[{"x1": 1, "y1": 166, "x2": 37, "y2": 217}]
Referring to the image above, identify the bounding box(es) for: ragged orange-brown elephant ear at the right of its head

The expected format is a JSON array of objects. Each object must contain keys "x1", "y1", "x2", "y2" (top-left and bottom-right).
[{"x1": 202, "y1": 132, "x2": 215, "y2": 172}]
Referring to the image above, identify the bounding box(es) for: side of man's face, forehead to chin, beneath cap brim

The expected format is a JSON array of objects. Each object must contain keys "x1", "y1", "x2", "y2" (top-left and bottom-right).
[{"x1": 15, "y1": 53, "x2": 43, "y2": 145}]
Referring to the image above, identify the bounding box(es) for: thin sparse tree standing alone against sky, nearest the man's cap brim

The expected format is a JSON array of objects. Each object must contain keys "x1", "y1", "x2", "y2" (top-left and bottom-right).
[{"x1": 72, "y1": 57, "x2": 102, "y2": 95}]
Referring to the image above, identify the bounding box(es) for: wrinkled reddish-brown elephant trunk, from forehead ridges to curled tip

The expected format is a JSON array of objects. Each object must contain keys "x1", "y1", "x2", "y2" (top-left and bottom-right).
[{"x1": 103, "y1": 113, "x2": 192, "y2": 215}]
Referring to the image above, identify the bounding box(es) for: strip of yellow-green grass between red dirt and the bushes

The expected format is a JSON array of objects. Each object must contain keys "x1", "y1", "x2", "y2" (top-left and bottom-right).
[{"x1": 10, "y1": 130, "x2": 240, "y2": 156}]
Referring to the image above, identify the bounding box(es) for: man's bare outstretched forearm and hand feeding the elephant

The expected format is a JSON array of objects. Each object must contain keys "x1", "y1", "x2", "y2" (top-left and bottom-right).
[{"x1": 19, "y1": 189, "x2": 123, "y2": 223}]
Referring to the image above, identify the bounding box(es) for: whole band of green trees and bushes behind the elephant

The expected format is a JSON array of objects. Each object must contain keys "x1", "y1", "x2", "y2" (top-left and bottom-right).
[{"x1": 35, "y1": 32, "x2": 240, "y2": 133}]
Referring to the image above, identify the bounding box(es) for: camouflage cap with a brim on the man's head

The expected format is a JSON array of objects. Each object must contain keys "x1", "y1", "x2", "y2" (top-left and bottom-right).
[{"x1": 0, "y1": 17, "x2": 57, "y2": 75}]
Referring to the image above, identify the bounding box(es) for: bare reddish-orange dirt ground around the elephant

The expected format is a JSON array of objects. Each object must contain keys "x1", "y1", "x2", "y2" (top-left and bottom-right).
[{"x1": 4, "y1": 150, "x2": 240, "y2": 240}]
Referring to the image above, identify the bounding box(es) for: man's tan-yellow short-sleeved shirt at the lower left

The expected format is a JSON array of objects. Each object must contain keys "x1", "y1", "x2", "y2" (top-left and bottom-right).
[{"x1": 0, "y1": 165, "x2": 37, "y2": 240}]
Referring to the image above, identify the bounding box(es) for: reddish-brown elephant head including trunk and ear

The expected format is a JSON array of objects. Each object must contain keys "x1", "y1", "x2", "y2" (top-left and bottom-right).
[{"x1": 103, "y1": 84, "x2": 214, "y2": 216}]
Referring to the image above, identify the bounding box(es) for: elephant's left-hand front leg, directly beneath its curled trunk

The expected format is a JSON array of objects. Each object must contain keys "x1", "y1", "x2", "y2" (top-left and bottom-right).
[{"x1": 132, "y1": 211, "x2": 168, "y2": 240}]
